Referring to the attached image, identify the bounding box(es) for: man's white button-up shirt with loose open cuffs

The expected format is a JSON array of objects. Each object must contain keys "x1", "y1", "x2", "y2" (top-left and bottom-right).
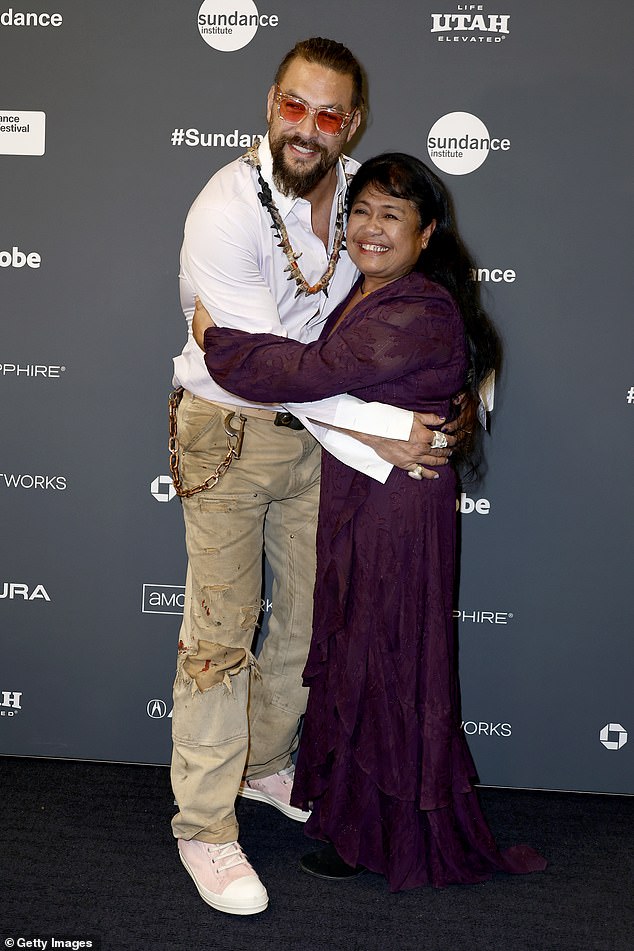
[{"x1": 173, "y1": 136, "x2": 413, "y2": 482}]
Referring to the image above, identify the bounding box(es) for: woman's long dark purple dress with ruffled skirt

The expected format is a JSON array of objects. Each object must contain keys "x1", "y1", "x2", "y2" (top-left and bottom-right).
[{"x1": 206, "y1": 273, "x2": 546, "y2": 891}]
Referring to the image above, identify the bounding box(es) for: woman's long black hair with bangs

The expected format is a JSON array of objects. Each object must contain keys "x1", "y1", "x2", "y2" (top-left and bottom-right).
[{"x1": 347, "y1": 152, "x2": 501, "y2": 468}]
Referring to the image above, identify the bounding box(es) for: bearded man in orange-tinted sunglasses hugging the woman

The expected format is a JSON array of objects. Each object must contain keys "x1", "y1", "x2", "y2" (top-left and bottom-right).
[{"x1": 172, "y1": 38, "x2": 454, "y2": 914}]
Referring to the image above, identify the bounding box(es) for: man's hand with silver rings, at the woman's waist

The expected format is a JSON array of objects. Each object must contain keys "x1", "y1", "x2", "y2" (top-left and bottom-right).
[{"x1": 350, "y1": 413, "x2": 458, "y2": 479}]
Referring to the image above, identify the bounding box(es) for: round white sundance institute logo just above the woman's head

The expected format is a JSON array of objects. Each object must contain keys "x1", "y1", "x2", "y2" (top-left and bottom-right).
[{"x1": 427, "y1": 112, "x2": 511, "y2": 175}]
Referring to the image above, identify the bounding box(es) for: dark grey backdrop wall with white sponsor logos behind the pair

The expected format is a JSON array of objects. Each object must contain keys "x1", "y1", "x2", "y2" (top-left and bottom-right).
[{"x1": 0, "y1": 0, "x2": 634, "y2": 793}]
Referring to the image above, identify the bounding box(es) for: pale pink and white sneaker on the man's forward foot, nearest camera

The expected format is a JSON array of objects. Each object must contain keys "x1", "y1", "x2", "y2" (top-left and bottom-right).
[{"x1": 178, "y1": 839, "x2": 269, "y2": 915}]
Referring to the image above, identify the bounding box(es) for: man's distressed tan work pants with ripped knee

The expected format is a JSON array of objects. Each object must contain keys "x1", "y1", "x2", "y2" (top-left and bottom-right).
[{"x1": 171, "y1": 392, "x2": 320, "y2": 842}]
